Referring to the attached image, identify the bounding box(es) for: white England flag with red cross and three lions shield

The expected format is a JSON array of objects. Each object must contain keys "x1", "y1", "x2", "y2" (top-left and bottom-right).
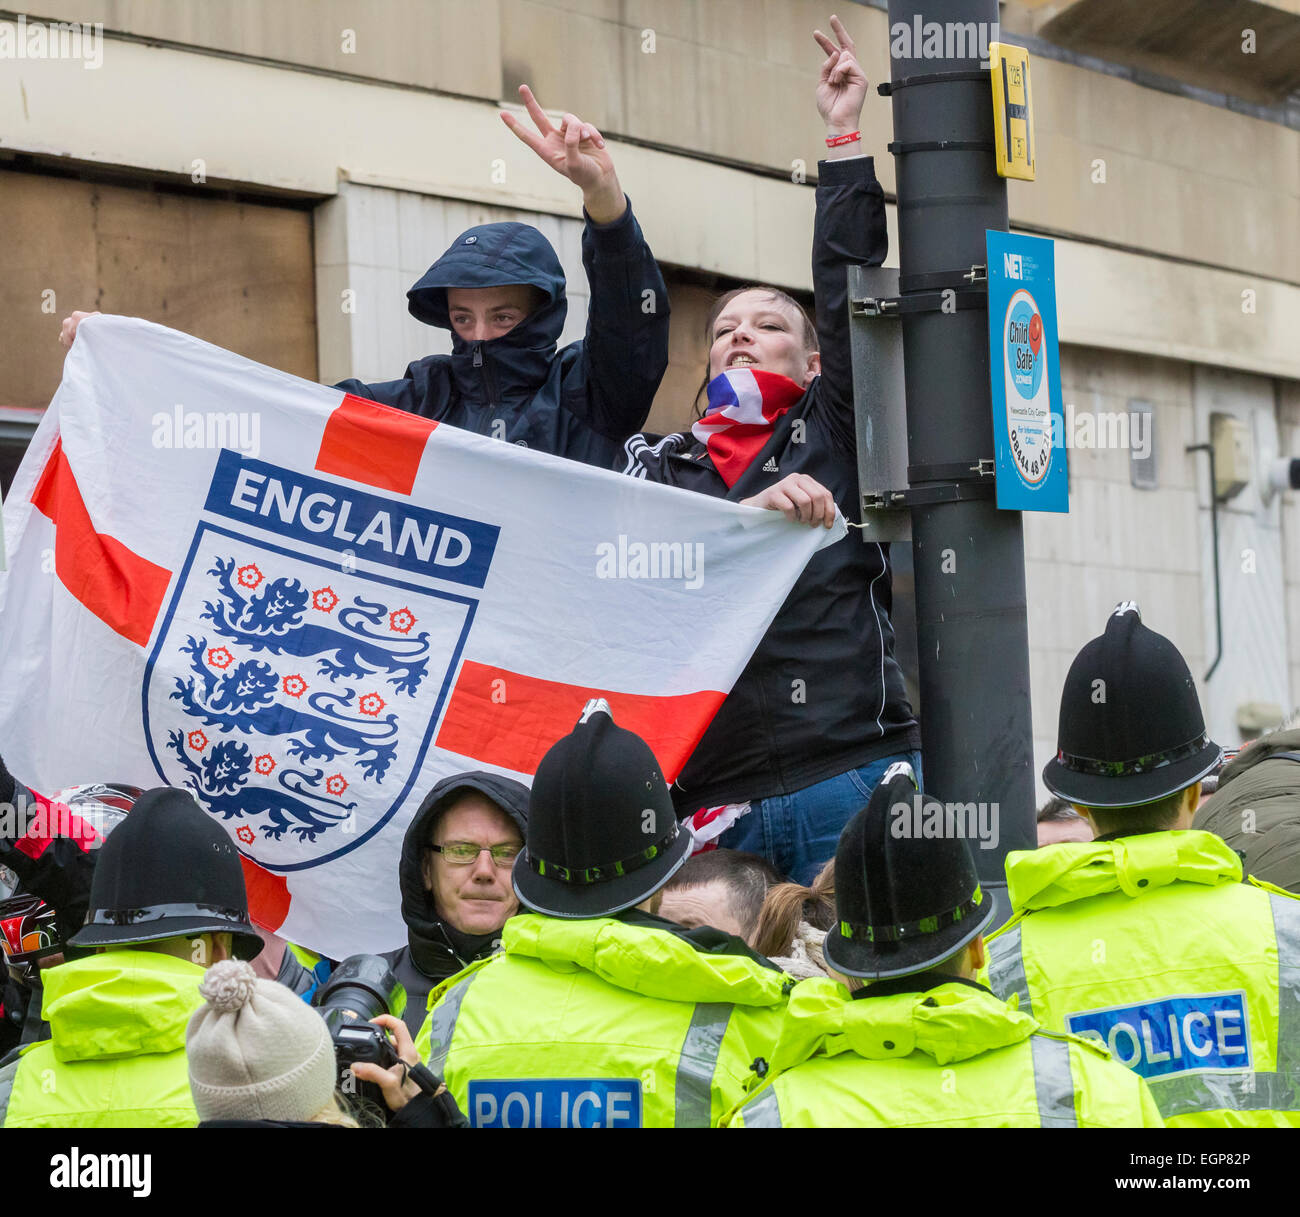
[{"x1": 0, "y1": 316, "x2": 845, "y2": 958}]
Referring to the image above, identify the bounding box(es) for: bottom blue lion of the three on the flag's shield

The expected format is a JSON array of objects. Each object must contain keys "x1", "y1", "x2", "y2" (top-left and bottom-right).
[{"x1": 166, "y1": 731, "x2": 356, "y2": 841}]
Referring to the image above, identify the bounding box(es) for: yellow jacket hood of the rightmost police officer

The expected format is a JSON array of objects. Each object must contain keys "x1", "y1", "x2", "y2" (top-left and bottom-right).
[{"x1": 1006, "y1": 831, "x2": 1242, "y2": 911}]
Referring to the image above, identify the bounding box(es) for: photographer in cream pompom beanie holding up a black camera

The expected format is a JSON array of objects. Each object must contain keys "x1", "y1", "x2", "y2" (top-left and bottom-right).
[{"x1": 186, "y1": 956, "x2": 465, "y2": 1129}]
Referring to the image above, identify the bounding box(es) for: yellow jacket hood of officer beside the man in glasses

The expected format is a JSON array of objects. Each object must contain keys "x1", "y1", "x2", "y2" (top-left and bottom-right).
[{"x1": 501, "y1": 913, "x2": 789, "y2": 1006}]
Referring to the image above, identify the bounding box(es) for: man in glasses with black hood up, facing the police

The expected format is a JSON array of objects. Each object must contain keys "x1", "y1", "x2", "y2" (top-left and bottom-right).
[{"x1": 384, "y1": 772, "x2": 528, "y2": 1036}]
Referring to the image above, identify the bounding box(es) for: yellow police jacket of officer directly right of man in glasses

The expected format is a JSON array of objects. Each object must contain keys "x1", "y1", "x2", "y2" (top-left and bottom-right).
[{"x1": 416, "y1": 914, "x2": 793, "y2": 1127}]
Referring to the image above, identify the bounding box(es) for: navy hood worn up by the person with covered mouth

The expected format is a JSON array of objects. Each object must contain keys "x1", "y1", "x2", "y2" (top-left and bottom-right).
[{"x1": 407, "y1": 224, "x2": 568, "y2": 351}]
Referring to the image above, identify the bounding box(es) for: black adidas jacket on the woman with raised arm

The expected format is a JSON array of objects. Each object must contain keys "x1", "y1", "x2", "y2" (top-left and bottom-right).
[{"x1": 619, "y1": 156, "x2": 920, "y2": 814}]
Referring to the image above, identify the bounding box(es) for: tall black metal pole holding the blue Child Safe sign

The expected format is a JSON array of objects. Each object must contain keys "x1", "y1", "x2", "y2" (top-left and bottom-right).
[{"x1": 889, "y1": 0, "x2": 1036, "y2": 910}]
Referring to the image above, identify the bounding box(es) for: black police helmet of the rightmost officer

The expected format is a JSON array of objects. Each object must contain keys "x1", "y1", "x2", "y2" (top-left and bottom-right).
[{"x1": 1043, "y1": 601, "x2": 1223, "y2": 807}]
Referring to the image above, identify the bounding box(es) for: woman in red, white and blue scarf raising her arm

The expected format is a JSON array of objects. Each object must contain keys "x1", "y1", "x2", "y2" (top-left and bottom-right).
[{"x1": 620, "y1": 17, "x2": 920, "y2": 884}]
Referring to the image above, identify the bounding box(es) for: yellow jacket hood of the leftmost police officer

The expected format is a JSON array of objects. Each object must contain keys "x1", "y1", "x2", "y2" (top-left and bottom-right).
[{"x1": 42, "y1": 950, "x2": 203, "y2": 1061}]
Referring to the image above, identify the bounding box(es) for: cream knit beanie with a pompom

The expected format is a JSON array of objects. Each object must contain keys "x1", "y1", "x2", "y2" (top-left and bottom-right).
[{"x1": 185, "y1": 960, "x2": 338, "y2": 1121}]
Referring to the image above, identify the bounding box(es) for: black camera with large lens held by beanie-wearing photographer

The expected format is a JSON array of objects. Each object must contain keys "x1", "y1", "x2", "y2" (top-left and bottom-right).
[{"x1": 312, "y1": 954, "x2": 406, "y2": 1113}]
